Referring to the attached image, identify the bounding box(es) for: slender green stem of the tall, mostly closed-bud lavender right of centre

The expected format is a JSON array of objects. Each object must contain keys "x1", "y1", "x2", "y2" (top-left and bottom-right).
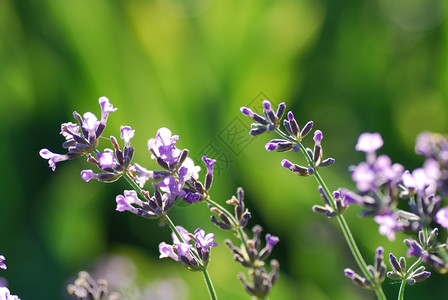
[{"x1": 276, "y1": 129, "x2": 387, "y2": 300}]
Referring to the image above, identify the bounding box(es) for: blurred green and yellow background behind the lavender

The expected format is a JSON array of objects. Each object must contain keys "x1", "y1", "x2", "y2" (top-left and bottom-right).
[{"x1": 0, "y1": 0, "x2": 448, "y2": 300}]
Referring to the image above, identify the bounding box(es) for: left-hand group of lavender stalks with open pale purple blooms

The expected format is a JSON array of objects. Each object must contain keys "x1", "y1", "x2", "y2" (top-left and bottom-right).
[{"x1": 40, "y1": 97, "x2": 279, "y2": 299}]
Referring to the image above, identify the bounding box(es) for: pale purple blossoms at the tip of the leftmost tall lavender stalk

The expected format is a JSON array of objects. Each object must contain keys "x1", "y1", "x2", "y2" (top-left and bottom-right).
[{"x1": 39, "y1": 97, "x2": 117, "y2": 171}]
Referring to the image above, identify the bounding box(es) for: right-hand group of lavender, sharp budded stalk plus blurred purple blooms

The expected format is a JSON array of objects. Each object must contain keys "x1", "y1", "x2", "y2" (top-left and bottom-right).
[{"x1": 241, "y1": 100, "x2": 448, "y2": 299}]
